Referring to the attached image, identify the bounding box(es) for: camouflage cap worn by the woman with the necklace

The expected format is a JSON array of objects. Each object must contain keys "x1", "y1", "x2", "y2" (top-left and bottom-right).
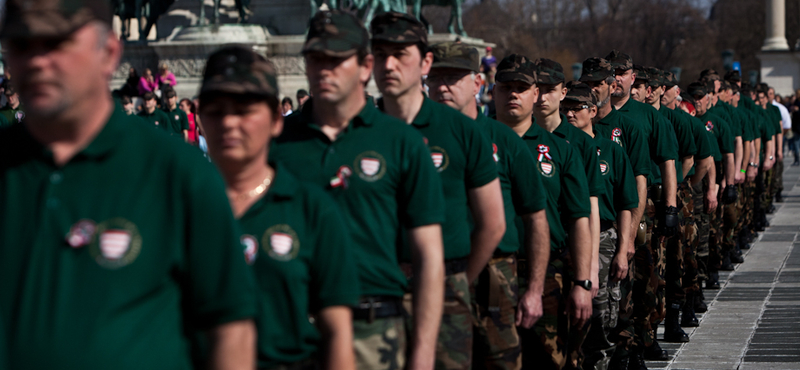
[{"x1": 200, "y1": 46, "x2": 278, "y2": 96}]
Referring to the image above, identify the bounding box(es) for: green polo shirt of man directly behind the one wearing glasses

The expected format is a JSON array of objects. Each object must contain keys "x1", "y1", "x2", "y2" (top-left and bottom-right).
[{"x1": 592, "y1": 105, "x2": 650, "y2": 177}]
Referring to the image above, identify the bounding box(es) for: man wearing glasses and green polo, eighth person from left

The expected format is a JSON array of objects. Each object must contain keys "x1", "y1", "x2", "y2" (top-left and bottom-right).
[{"x1": 562, "y1": 82, "x2": 639, "y2": 369}]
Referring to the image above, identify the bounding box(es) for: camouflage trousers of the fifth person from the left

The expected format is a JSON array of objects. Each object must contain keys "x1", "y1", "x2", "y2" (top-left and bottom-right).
[{"x1": 472, "y1": 255, "x2": 522, "y2": 370}]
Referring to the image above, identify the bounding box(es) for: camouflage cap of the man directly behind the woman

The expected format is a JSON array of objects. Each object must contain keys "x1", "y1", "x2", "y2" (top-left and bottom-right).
[{"x1": 302, "y1": 10, "x2": 369, "y2": 58}]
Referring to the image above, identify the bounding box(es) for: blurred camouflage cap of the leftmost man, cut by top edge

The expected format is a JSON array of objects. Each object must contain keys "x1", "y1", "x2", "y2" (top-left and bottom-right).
[{"x1": 0, "y1": 0, "x2": 113, "y2": 38}]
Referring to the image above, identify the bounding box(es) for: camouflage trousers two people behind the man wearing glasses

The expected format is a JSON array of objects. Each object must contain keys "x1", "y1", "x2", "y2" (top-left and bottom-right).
[{"x1": 632, "y1": 198, "x2": 663, "y2": 347}]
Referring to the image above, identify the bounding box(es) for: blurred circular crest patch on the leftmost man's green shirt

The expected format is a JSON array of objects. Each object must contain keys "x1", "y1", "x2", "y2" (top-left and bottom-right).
[{"x1": 89, "y1": 217, "x2": 142, "y2": 269}]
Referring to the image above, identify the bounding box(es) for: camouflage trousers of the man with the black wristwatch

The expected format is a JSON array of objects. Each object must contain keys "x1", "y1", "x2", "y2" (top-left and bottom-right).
[{"x1": 518, "y1": 248, "x2": 572, "y2": 370}]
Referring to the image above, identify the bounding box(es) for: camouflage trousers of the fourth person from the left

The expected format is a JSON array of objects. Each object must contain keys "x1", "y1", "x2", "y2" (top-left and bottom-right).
[{"x1": 434, "y1": 272, "x2": 473, "y2": 370}]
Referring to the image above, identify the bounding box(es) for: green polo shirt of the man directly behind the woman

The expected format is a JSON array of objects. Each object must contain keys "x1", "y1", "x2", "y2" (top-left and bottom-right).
[{"x1": 270, "y1": 100, "x2": 446, "y2": 297}]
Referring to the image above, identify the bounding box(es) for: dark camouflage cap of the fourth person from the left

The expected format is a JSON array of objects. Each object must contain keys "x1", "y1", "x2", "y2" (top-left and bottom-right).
[{"x1": 369, "y1": 12, "x2": 428, "y2": 45}]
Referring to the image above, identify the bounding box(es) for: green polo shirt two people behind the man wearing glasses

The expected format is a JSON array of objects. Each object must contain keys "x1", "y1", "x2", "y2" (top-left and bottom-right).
[{"x1": 619, "y1": 98, "x2": 678, "y2": 184}]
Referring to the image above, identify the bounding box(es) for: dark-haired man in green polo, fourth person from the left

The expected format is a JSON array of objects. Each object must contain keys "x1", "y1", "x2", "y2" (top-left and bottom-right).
[{"x1": 370, "y1": 12, "x2": 506, "y2": 369}]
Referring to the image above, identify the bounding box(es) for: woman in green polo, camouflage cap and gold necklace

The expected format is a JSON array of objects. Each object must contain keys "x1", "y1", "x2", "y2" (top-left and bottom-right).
[{"x1": 199, "y1": 47, "x2": 359, "y2": 369}]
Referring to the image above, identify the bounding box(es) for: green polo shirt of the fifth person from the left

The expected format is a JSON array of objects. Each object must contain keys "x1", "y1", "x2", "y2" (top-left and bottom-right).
[{"x1": 475, "y1": 114, "x2": 547, "y2": 253}]
